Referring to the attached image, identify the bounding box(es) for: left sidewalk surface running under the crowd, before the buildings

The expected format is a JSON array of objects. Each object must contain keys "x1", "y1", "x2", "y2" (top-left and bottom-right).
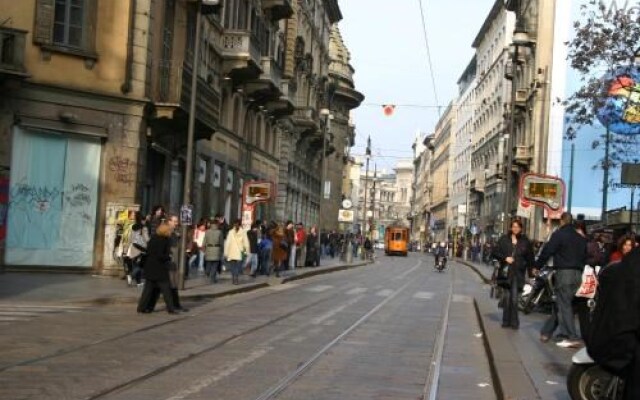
[{"x1": 0, "y1": 257, "x2": 367, "y2": 305}]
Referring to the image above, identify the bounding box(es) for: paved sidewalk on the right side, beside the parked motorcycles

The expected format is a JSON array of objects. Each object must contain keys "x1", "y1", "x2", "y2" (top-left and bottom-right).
[{"x1": 456, "y1": 259, "x2": 576, "y2": 400}]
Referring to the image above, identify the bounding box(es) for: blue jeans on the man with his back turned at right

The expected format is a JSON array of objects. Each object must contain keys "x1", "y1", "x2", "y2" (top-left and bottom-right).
[{"x1": 555, "y1": 269, "x2": 582, "y2": 340}]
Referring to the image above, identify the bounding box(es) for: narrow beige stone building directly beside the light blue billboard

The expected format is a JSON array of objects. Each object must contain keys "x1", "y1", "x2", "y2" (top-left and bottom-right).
[{"x1": 505, "y1": 0, "x2": 565, "y2": 239}]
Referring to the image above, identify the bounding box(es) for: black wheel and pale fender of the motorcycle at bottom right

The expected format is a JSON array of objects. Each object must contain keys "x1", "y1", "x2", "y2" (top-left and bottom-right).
[{"x1": 567, "y1": 348, "x2": 624, "y2": 400}]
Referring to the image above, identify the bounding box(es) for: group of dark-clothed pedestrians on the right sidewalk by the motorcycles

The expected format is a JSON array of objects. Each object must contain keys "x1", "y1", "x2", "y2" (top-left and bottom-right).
[{"x1": 491, "y1": 213, "x2": 640, "y2": 399}]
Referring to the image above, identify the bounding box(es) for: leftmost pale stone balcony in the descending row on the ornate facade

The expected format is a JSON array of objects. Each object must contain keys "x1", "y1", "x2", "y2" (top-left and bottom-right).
[{"x1": 220, "y1": 30, "x2": 262, "y2": 80}]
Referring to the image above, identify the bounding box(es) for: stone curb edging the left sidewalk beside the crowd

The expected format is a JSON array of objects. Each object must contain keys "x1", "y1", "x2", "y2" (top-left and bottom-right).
[{"x1": 64, "y1": 262, "x2": 370, "y2": 306}]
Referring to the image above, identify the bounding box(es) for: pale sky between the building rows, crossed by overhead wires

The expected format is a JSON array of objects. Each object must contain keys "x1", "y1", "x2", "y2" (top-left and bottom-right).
[{"x1": 339, "y1": 0, "x2": 494, "y2": 170}]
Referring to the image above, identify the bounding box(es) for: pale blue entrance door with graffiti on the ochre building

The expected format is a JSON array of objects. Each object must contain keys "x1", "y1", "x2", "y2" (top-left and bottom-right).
[{"x1": 5, "y1": 127, "x2": 101, "y2": 267}]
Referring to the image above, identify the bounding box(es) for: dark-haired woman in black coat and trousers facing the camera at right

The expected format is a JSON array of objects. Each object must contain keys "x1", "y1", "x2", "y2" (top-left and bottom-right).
[{"x1": 493, "y1": 220, "x2": 534, "y2": 329}]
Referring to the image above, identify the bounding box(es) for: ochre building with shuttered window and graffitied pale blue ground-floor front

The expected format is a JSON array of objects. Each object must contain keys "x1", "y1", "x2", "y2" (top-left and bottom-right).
[{"x1": 0, "y1": 0, "x2": 150, "y2": 270}]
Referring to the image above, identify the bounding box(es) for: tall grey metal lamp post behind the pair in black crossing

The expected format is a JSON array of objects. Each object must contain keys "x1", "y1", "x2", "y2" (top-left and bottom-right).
[{"x1": 178, "y1": 0, "x2": 202, "y2": 290}]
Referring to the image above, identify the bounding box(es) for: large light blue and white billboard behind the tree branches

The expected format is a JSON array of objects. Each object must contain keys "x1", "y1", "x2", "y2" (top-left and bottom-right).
[{"x1": 547, "y1": 0, "x2": 640, "y2": 210}]
